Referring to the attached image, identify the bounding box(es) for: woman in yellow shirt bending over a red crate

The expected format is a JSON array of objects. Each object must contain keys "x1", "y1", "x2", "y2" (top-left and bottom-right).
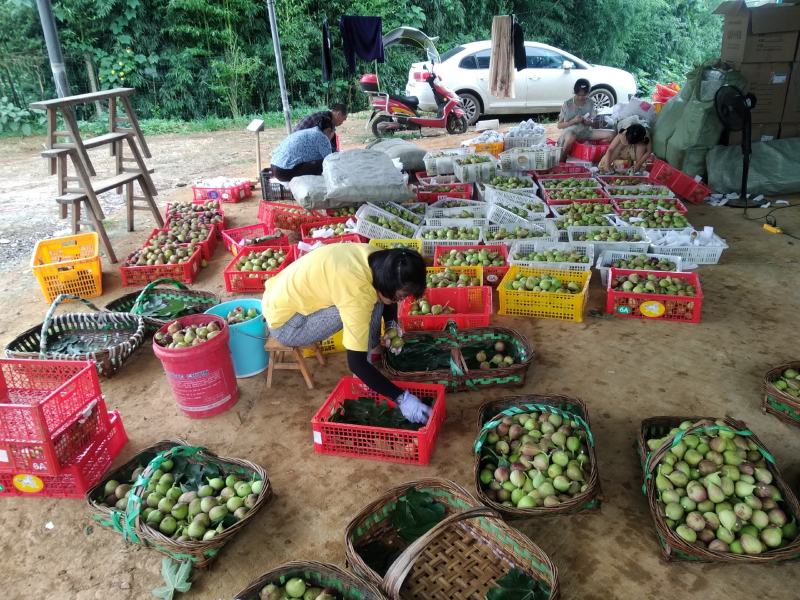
[{"x1": 262, "y1": 244, "x2": 430, "y2": 423}]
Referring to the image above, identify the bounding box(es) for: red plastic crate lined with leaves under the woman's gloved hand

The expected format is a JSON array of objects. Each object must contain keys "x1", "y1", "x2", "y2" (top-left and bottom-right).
[{"x1": 311, "y1": 377, "x2": 447, "y2": 465}]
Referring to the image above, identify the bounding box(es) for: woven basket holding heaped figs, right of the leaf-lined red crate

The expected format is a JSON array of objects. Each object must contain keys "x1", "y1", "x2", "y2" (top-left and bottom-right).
[{"x1": 474, "y1": 394, "x2": 602, "y2": 519}]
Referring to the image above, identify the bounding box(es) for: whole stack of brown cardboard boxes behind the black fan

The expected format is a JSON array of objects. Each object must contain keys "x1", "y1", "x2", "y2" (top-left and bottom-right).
[{"x1": 716, "y1": 0, "x2": 800, "y2": 144}]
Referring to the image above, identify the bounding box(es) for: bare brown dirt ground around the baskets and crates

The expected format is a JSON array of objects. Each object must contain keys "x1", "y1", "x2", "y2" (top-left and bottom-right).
[{"x1": 0, "y1": 119, "x2": 800, "y2": 600}]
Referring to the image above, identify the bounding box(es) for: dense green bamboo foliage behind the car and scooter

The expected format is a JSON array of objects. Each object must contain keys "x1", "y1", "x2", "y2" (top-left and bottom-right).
[{"x1": 0, "y1": 0, "x2": 721, "y2": 125}]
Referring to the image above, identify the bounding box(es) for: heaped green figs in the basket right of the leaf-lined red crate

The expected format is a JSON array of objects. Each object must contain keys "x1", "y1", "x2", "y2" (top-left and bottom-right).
[{"x1": 480, "y1": 411, "x2": 591, "y2": 508}]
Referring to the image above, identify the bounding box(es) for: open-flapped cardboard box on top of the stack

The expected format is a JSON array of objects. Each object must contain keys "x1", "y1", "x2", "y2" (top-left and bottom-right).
[{"x1": 714, "y1": 0, "x2": 800, "y2": 66}]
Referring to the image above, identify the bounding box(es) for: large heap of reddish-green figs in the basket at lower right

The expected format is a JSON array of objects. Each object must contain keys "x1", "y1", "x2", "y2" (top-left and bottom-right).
[{"x1": 647, "y1": 420, "x2": 797, "y2": 555}]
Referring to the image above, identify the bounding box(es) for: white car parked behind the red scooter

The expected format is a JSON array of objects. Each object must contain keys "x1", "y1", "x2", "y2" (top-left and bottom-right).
[{"x1": 406, "y1": 40, "x2": 636, "y2": 125}]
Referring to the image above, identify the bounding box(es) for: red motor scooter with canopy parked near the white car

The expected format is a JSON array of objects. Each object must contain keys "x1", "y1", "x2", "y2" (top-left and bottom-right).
[{"x1": 360, "y1": 27, "x2": 467, "y2": 138}]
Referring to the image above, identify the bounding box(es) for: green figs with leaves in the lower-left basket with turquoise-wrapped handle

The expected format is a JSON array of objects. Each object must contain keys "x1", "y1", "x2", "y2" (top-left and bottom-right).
[{"x1": 96, "y1": 457, "x2": 264, "y2": 542}]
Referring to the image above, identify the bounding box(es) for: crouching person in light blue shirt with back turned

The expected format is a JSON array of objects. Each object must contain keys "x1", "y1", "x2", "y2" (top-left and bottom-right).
[{"x1": 272, "y1": 117, "x2": 334, "y2": 181}]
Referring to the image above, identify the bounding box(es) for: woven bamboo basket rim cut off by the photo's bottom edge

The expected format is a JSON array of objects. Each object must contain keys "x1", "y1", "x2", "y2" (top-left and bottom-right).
[{"x1": 234, "y1": 561, "x2": 386, "y2": 600}]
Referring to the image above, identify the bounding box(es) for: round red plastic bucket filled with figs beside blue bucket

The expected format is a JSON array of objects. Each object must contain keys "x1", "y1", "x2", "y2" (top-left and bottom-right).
[{"x1": 153, "y1": 315, "x2": 239, "y2": 419}]
